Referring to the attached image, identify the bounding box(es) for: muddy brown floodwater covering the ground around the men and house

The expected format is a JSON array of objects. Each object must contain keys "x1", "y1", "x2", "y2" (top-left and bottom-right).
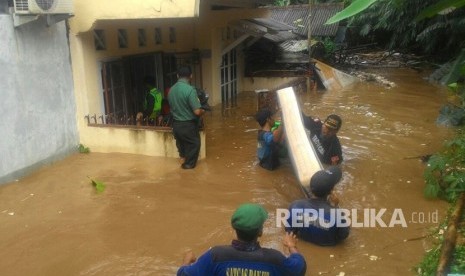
[{"x1": 0, "y1": 69, "x2": 453, "y2": 275}]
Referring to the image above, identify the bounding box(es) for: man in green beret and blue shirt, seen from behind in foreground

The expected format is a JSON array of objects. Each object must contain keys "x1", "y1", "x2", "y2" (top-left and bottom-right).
[{"x1": 177, "y1": 203, "x2": 307, "y2": 276}]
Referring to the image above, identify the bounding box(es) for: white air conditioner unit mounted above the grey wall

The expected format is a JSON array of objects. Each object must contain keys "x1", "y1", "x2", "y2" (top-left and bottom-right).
[{"x1": 14, "y1": 0, "x2": 74, "y2": 14}]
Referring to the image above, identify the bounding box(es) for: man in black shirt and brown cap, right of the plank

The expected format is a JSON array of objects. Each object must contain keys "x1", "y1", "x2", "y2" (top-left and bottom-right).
[{"x1": 302, "y1": 112, "x2": 343, "y2": 165}]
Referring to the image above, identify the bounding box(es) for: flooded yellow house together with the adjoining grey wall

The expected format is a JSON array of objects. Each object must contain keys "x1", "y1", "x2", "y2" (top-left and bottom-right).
[{"x1": 0, "y1": 0, "x2": 342, "y2": 183}]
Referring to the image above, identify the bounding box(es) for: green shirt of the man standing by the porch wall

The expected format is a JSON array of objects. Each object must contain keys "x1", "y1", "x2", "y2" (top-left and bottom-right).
[{"x1": 168, "y1": 79, "x2": 200, "y2": 121}]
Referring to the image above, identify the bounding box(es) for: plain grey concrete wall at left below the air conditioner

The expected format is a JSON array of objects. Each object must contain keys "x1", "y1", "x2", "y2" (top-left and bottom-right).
[{"x1": 0, "y1": 13, "x2": 79, "y2": 183}]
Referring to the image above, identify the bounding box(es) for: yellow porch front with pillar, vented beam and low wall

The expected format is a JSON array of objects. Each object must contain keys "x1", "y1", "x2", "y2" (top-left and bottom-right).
[{"x1": 70, "y1": 18, "x2": 206, "y2": 159}]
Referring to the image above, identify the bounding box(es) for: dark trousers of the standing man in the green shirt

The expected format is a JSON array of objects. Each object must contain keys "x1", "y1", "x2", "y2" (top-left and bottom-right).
[{"x1": 173, "y1": 120, "x2": 200, "y2": 167}]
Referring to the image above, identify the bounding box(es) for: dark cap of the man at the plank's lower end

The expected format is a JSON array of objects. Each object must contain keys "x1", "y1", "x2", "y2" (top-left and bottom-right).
[{"x1": 310, "y1": 166, "x2": 342, "y2": 197}]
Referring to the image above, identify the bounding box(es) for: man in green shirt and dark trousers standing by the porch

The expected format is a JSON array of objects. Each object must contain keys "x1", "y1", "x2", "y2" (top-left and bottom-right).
[{"x1": 168, "y1": 66, "x2": 205, "y2": 169}]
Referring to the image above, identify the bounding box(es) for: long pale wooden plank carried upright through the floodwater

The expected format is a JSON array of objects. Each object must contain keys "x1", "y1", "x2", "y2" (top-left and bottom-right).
[{"x1": 276, "y1": 87, "x2": 323, "y2": 195}]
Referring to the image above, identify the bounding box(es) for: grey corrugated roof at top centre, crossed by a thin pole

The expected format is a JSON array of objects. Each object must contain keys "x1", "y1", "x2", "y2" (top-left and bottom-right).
[{"x1": 267, "y1": 3, "x2": 344, "y2": 37}]
